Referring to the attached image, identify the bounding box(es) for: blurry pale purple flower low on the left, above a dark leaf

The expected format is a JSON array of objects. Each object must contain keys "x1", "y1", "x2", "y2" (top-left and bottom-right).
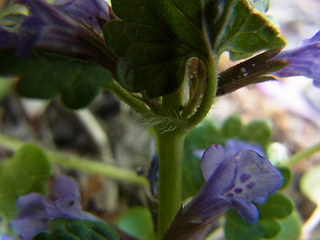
[{"x1": 11, "y1": 175, "x2": 96, "y2": 240}]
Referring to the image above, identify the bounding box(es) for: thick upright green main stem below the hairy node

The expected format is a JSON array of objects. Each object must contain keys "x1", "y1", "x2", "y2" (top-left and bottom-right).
[{"x1": 156, "y1": 131, "x2": 184, "y2": 239}]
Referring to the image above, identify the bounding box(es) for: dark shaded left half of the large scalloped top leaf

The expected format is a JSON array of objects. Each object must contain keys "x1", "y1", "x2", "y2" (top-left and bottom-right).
[{"x1": 104, "y1": 0, "x2": 206, "y2": 97}]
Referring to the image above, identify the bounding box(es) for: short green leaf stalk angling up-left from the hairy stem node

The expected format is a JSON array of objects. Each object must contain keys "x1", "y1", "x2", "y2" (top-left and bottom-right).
[{"x1": 111, "y1": 81, "x2": 151, "y2": 113}]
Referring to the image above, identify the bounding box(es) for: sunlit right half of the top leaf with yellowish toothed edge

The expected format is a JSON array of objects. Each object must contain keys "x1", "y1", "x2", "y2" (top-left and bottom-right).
[{"x1": 207, "y1": 0, "x2": 285, "y2": 60}]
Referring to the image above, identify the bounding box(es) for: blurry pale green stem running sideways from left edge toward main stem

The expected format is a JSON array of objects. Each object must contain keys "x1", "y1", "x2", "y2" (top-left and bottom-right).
[{"x1": 0, "y1": 134, "x2": 149, "y2": 187}]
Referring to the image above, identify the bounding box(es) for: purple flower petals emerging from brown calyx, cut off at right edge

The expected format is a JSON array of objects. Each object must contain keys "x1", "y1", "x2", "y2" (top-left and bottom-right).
[{"x1": 273, "y1": 31, "x2": 320, "y2": 87}]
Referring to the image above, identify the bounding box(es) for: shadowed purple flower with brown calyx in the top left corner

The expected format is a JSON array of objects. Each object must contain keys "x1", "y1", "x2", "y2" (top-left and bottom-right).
[{"x1": 0, "y1": 0, "x2": 114, "y2": 69}]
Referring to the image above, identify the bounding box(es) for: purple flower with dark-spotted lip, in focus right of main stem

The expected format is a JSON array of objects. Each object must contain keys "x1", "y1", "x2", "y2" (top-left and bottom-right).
[{"x1": 165, "y1": 145, "x2": 282, "y2": 239}]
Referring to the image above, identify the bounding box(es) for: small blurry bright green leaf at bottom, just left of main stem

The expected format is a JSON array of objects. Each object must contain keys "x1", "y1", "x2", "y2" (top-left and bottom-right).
[{"x1": 118, "y1": 207, "x2": 155, "y2": 240}]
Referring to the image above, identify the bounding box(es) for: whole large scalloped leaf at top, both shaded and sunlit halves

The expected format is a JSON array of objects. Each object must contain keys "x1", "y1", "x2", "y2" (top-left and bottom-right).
[{"x1": 104, "y1": 0, "x2": 284, "y2": 97}]
